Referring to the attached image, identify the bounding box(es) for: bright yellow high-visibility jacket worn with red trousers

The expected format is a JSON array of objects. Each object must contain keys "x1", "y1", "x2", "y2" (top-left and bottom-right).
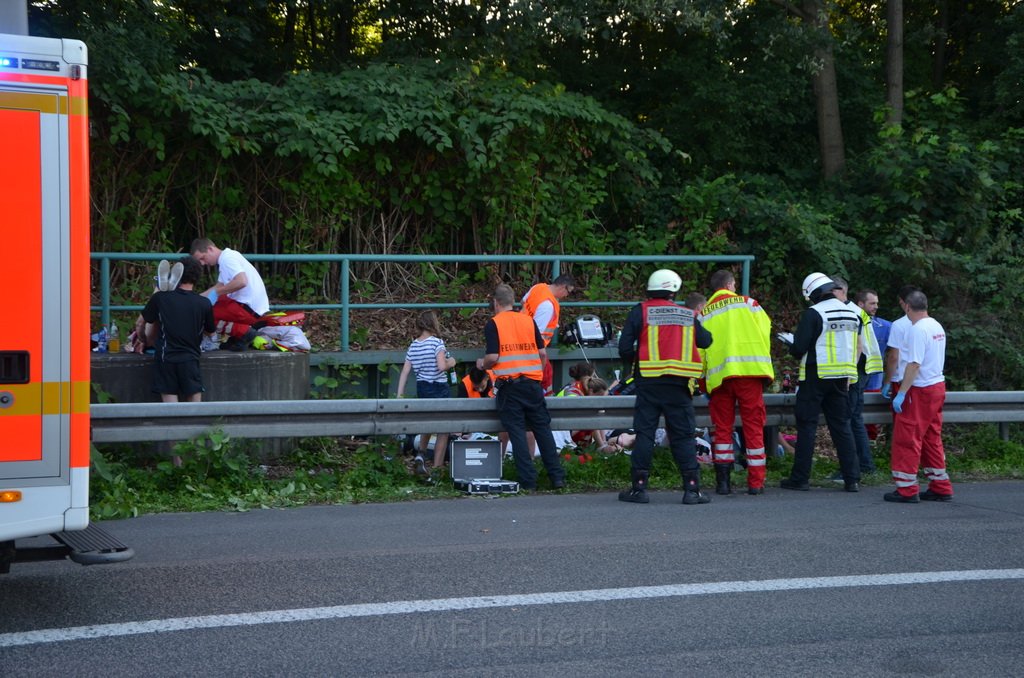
[{"x1": 699, "y1": 290, "x2": 775, "y2": 392}]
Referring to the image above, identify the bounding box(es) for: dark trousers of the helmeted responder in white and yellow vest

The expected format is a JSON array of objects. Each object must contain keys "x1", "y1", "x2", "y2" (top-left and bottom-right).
[{"x1": 790, "y1": 378, "x2": 860, "y2": 482}]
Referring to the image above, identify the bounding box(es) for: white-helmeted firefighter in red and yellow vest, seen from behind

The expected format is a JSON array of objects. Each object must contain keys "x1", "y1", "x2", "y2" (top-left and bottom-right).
[{"x1": 618, "y1": 268, "x2": 712, "y2": 504}]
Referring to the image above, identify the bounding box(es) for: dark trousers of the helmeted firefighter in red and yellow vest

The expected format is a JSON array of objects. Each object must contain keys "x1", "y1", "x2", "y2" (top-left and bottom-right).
[{"x1": 631, "y1": 379, "x2": 700, "y2": 473}]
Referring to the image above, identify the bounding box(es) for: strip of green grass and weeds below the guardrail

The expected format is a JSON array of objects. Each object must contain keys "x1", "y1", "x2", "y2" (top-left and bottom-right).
[{"x1": 90, "y1": 424, "x2": 1024, "y2": 519}]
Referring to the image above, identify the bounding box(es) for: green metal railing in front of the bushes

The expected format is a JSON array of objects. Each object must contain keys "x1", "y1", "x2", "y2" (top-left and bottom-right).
[{"x1": 91, "y1": 252, "x2": 754, "y2": 351}]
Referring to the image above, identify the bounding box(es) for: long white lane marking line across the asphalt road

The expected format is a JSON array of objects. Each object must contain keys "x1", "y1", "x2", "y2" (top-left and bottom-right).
[{"x1": 0, "y1": 569, "x2": 1024, "y2": 647}]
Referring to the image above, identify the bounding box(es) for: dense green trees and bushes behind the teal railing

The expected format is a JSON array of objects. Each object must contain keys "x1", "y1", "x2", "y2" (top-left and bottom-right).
[{"x1": 31, "y1": 0, "x2": 1024, "y2": 388}]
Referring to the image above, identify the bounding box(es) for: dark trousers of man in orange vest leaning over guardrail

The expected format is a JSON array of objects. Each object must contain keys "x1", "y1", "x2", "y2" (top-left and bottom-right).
[{"x1": 495, "y1": 380, "x2": 565, "y2": 490}]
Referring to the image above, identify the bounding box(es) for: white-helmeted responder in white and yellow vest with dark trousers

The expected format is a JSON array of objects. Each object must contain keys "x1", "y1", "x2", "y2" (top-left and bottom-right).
[{"x1": 779, "y1": 272, "x2": 864, "y2": 492}]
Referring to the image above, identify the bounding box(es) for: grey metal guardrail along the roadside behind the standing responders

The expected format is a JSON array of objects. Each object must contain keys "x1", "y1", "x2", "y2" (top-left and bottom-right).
[{"x1": 91, "y1": 391, "x2": 1024, "y2": 442}]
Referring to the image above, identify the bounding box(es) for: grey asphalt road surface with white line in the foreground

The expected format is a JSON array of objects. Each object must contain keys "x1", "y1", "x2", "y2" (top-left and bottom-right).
[{"x1": 0, "y1": 482, "x2": 1024, "y2": 678}]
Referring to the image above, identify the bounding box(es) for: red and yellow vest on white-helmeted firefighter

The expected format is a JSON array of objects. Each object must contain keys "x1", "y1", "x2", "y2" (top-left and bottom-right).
[{"x1": 637, "y1": 299, "x2": 703, "y2": 378}]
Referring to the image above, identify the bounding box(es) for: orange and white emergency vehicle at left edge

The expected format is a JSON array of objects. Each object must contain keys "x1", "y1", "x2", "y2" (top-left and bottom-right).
[{"x1": 0, "y1": 34, "x2": 132, "y2": 574}]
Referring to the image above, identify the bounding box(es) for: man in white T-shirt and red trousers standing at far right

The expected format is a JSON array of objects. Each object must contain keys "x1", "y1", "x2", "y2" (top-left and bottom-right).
[{"x1": 885, "y1": 291, "x2": 953, "y2": 504}]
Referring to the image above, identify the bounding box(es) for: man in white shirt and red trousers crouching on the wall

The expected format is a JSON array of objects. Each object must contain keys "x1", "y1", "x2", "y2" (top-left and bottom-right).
[{"x1": 190, "y1": 238, "x2": 270, "y2": 350}]
